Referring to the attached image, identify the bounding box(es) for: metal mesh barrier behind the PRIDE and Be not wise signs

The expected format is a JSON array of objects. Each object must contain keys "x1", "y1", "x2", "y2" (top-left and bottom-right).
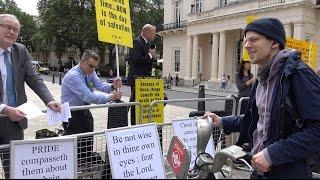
[{"x1": 0, "y1": 123, "x2": 173, "y2": 179}]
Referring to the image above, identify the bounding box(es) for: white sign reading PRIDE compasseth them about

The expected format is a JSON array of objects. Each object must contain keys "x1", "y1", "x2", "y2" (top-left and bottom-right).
[{"x1": 10, "y1": 137, "x2": 77, "y2": 179}]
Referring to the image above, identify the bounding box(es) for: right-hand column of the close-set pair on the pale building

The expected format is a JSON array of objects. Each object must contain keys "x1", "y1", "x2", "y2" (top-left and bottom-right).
[{"x1": 218, "y1": 31, "x2": 226, "y2": 79}]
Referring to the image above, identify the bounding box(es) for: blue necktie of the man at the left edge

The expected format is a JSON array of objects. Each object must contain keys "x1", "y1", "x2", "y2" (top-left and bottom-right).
[{"x1": 4, "y1": 50, "x2": 16, "y2": 107}]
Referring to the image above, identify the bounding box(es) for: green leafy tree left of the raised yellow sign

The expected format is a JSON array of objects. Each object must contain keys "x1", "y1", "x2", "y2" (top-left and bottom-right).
[{"x1": 38, "y1": 0, "x2": 106, "y2": 62}]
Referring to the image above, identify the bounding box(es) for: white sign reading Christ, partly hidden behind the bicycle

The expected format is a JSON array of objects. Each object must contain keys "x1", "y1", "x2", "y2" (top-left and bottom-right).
[{"x1": 172, "y1": 118, "x2": 215, "y2": 169}]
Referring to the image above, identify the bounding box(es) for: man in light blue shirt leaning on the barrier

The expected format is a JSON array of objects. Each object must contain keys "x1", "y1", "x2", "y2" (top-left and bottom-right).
[{"x1": 61, "y1": 50, "x2": 121, "y2": 162}]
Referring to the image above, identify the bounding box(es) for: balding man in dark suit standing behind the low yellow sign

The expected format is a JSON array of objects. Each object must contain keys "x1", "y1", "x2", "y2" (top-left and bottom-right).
[{"x1": 129, "y1": 24, "x2": 157, "y2": 125}]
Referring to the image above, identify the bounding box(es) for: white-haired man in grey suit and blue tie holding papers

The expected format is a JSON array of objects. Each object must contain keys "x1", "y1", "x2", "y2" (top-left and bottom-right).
[{"x1": 0, "y1": 14, "x2": 61, "y2": 178}]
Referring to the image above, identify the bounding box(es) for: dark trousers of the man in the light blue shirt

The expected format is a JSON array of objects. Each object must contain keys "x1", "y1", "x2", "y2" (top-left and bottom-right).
[{"x1": 63, "y1": 110, "x2": 93, "y2": 162}]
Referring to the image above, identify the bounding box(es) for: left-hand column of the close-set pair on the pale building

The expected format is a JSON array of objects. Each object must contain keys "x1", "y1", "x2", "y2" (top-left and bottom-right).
[{"x1": 210, "y1": 32, "x2": 219, "y2": 81}]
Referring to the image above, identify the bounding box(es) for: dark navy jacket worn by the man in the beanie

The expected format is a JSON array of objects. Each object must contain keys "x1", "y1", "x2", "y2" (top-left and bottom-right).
[{"x1": 222, "y1": 52, "x2": 320, "y2": 178}]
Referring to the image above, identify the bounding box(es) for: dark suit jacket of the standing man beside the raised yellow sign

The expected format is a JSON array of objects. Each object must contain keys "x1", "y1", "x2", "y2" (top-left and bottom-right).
[{"x1": 129, "y1": 36, "x2": 154, "y2": 82}]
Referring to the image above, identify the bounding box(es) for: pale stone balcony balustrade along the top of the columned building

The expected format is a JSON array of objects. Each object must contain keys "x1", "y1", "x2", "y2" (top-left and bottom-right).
[{"x1": 188, "y1": 0, "x2": 319, "y2": 22}]
